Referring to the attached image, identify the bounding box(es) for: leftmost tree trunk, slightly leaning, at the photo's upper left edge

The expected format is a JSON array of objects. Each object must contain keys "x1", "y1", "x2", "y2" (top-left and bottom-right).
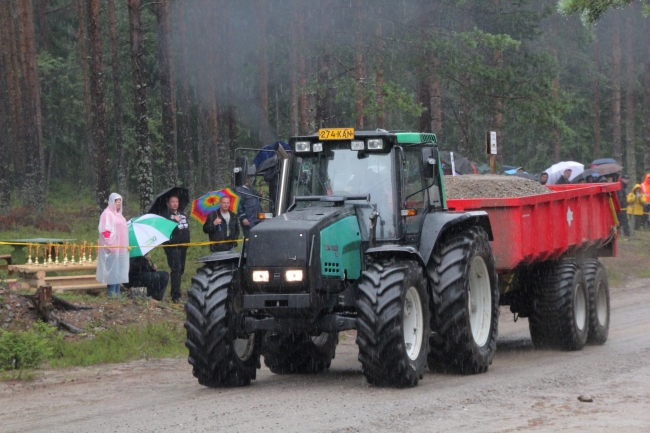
[{"x1": 0, "y1": 0, "x2": 25, "y2": 182}]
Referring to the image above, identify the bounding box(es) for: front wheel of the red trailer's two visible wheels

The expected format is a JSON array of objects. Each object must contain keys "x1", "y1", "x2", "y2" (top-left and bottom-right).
[{"x1": 528, "y1": 260, "x2": 589, "y2": 350}]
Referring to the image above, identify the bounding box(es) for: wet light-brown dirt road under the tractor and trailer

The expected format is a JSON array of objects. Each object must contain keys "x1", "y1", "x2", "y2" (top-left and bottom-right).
[{"x1": 0, "y1": 279, "x2": 650, "y2": 433}]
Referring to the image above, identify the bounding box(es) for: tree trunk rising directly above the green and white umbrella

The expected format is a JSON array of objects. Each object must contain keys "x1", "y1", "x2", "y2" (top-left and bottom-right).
[{"x1": 129, "y1": 0, "x2": 154, "y2": 213}]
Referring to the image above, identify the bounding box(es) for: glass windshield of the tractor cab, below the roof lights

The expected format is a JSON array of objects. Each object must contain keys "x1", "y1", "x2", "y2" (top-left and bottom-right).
[{"x1": 289, "y1": 143, "x2": 397, "y2": 239}]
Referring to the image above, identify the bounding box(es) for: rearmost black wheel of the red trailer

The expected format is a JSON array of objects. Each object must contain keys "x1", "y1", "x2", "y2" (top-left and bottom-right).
[{"x1": 580, "y1": 259, "x2": 610, "y2": 344}]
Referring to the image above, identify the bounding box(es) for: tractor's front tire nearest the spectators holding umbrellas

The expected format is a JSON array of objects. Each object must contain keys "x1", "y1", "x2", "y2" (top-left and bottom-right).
[{"x1": 185, "y1": 263, "x2": 260, "y2": 387}]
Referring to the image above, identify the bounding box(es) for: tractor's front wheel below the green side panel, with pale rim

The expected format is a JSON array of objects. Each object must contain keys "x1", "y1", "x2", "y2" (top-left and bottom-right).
[{"x1": 357, "y1": 260, "x2": 430, "y2": 387}]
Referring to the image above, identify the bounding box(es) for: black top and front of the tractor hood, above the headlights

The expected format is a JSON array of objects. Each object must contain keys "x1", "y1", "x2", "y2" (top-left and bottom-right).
[{"x1": 246, "y1": 205, "x2": 356, "y2": 268}]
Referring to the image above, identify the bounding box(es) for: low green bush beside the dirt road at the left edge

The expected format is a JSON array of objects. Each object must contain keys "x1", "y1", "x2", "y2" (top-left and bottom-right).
[{"x1": 0, "y1": 322, "x2": 62, "y2": 371}]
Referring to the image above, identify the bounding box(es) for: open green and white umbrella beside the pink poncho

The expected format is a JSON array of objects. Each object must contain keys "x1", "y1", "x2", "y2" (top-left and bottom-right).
[{"x1": 126, "y1": 213, "x2": 178, "y2": 257}]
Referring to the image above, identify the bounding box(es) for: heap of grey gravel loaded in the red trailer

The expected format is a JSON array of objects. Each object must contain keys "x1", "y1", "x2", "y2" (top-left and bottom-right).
[{"x1": 445, "y1": 174, "x2": 549, "y2": 200}]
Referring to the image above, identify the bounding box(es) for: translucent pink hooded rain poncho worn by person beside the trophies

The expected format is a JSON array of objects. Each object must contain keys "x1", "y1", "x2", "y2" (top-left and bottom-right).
[{"x1": 97, "y1": 193, "x2": 129, "y2": 284}]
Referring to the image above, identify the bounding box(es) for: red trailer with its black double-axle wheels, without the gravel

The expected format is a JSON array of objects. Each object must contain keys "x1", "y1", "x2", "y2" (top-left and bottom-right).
[{"x1": 447, "y1": 184, "x2": 620, "y2": 350}]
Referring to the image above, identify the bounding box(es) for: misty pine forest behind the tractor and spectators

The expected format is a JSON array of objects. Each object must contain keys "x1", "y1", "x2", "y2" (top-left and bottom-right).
[{"x1": 0, "y1": 0, "x2": 650, "y2": 215}]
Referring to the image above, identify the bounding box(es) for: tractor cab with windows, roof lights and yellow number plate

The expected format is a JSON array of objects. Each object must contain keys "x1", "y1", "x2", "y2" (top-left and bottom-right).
[{"x1": 285, "y1": 128, "x2": 444, "y2": 243}]
